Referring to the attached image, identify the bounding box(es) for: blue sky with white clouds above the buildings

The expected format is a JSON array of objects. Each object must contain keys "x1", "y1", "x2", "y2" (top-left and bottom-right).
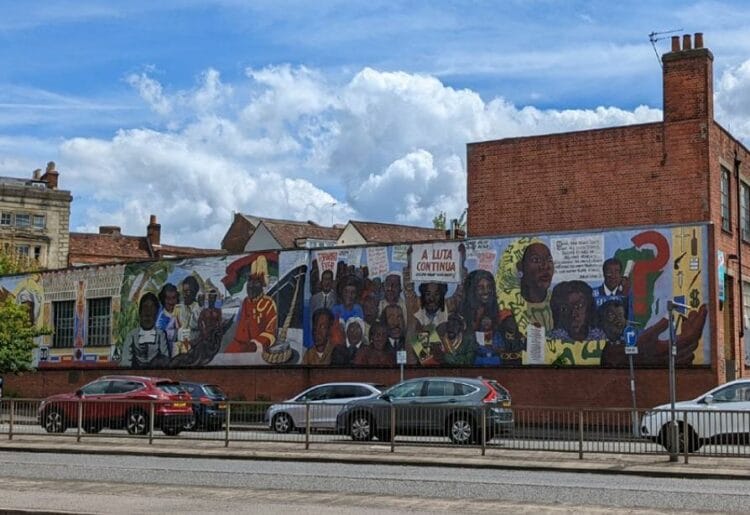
[{"x1": 0, "y1": 0, "x2": 750, "y2": 248}]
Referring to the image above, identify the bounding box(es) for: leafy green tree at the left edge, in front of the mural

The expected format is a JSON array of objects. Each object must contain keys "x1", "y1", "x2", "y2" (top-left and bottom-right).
[{"x1": 0, "y1": 299, "x2": 51, "y2": 373}]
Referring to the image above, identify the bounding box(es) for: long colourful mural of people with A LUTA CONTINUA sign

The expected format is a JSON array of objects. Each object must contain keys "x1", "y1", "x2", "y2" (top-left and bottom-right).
[{"x1": 0, "y1": 225, "x2": 711, "y2": 369}]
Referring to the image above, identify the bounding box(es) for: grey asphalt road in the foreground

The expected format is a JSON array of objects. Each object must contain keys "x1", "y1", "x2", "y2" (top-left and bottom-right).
[{"x1": 0, "y1": 451, "x2": 750, "y2": 514}]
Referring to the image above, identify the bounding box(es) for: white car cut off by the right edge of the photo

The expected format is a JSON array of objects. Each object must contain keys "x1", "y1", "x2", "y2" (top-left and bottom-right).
[{"x1": 641, "y1": 379, "x2": 750, "y2": 452}]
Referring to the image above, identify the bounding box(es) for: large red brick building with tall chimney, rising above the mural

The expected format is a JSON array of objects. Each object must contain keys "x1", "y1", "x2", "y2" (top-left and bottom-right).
[{"x1": 467, "y1": 33, "x2": 750, "y2": 396}]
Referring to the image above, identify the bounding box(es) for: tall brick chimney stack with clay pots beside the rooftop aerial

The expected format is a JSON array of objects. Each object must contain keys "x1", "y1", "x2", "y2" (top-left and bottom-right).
[{"x1": 662, "y1": 32, "x2": 714, "y2": 122}]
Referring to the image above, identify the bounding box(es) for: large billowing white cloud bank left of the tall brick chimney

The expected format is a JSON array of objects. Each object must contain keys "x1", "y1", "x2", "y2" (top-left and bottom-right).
[{"x1": 45, "y1": 65, "x2": 676, "y2": 247}]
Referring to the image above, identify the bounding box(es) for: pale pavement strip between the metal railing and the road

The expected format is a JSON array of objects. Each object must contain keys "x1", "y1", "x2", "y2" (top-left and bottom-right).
[{"x1": 0, "y1": 435, "x2": 750, "y2": 480}]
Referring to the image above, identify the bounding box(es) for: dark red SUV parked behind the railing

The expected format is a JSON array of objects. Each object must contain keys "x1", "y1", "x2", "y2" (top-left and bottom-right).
[{"x1": 37, "y1": 375, "x2": 193, "y2": 436}]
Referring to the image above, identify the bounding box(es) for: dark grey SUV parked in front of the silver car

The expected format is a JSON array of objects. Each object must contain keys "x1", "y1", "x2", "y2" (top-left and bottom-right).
[{"x1": 336, "y1": 377, "x2": 513, "y2": 444}]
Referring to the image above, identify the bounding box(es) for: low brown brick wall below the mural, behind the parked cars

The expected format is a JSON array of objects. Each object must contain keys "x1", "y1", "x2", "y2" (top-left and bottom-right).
[{"x1": 5, "y1": 367, "x2": 715, "y2": 408}]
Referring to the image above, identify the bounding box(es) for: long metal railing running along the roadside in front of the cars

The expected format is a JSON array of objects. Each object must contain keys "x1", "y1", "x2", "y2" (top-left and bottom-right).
[{"x1": 0, "y1": 399, "x2": 750, "y2": 462}]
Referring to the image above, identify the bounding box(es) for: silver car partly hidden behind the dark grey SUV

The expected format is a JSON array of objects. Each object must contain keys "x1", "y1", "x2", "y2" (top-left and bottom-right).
[{"x1": 265, "y1": 383, "x2": 383, "y2": 433}]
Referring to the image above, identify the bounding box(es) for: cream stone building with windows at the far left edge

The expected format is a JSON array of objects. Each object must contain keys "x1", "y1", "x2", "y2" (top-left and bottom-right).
[{"x1": 0, "y1": 162, "x2": 73, "y2": 269}]
